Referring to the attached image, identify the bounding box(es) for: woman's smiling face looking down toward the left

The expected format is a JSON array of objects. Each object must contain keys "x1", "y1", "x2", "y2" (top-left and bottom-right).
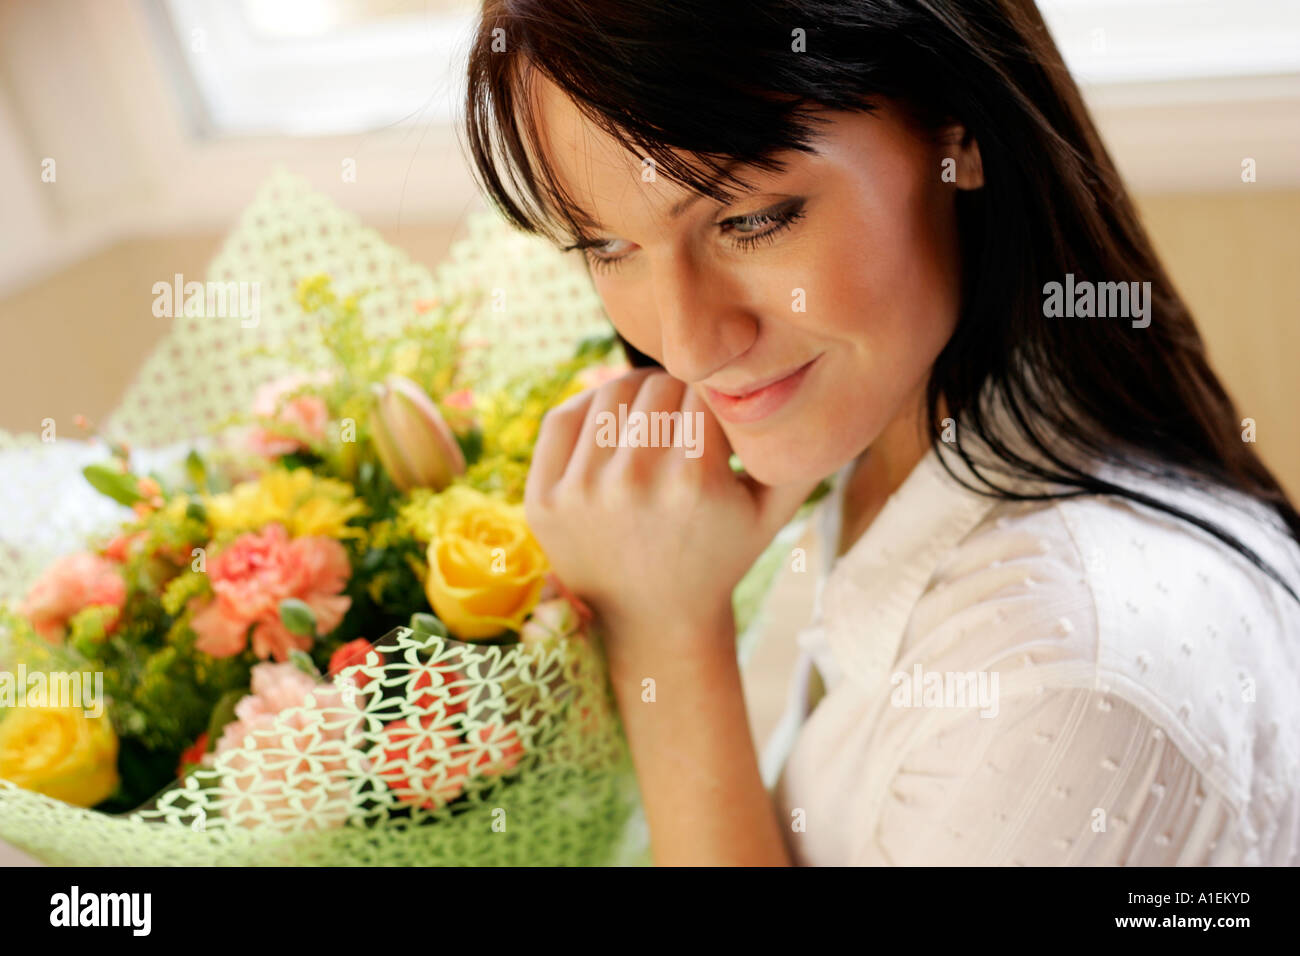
[{"x1": 525, "y1": 77, "x2": 980, "y2": 485}]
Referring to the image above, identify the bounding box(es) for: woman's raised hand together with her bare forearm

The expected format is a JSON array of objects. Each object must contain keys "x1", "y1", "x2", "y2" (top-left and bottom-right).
[{"x1": 524, "y1": 368, "x2": 813, "y2": 866}]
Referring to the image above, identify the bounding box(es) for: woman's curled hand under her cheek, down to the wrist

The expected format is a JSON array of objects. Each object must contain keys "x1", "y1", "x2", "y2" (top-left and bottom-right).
[{"x1": 524, "y1": 368, "x2": 815, "y2": 650}]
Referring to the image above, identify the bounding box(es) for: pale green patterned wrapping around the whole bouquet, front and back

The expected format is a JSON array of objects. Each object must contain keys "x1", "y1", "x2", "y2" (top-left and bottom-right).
[{"x1": 0, "y1": 173, "x2": 807, "y2": 865}]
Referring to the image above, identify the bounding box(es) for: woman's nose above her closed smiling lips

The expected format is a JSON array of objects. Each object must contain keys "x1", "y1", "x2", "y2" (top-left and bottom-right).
[{"x1": 651, "y1": 256, "x2": 758, "y2": 382}]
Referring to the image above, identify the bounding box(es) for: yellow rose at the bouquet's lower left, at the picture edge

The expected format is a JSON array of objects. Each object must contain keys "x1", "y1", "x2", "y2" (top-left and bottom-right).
[{"x1": 0, "y1": 706, "x2": 117, "y2": 806}]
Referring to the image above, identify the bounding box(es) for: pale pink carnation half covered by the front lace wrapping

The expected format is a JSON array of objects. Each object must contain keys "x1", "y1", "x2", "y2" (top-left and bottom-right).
[{"x1": 203, "y1": 663, "x2": 369, "y2": 830}]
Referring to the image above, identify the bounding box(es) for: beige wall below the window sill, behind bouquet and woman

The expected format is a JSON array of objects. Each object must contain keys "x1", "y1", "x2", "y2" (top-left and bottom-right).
[{"x1": 0, "y1": 187, "x2": 1300, "y2": 496}]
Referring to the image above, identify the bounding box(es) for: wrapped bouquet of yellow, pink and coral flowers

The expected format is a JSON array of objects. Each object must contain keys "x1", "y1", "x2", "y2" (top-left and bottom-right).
[{"x1": 0, "y1": 177, "x2": 802, "y2": 865}]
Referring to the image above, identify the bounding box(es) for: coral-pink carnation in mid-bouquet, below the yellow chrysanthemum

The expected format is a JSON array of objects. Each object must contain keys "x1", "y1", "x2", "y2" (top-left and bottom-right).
[{"x1": 190, "y1": 524, "x2": 352, "y2": 661}]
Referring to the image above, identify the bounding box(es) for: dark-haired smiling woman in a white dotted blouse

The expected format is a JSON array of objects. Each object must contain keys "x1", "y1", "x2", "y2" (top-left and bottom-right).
[{"x1": 467, "y1": 0, "x2": 1300, "y2": 865}]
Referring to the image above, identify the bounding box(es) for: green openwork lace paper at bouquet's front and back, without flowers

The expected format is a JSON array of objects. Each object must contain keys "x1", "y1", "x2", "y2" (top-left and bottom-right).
[{"x1": 0, "y1": 173, "x2": 807, "y2": 866}]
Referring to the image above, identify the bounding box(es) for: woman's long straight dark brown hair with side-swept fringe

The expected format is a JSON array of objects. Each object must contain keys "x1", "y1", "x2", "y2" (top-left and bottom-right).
[{"x1": 465, "y1": 0, "x2": 1300, "y2": 600}]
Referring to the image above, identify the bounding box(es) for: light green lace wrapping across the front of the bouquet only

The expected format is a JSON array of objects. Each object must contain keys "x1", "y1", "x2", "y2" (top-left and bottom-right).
[{"x1": 0, "y1": 628, "x2": 637, "y2": 866}]
